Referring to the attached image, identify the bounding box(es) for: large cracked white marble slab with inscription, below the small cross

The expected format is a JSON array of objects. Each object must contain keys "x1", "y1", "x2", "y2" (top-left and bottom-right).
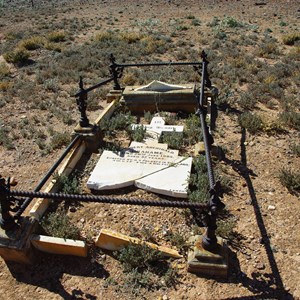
[{"x1": 87, "y1": 142, "x2": 192, "y2": 198}]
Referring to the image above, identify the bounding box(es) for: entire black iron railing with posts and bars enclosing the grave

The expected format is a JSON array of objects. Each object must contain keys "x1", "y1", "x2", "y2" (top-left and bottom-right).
[{"x1": 0, "y1": 51, "x2": 224, "y2": 250}]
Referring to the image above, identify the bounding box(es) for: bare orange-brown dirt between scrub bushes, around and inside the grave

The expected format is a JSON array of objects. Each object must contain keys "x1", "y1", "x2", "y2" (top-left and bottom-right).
[{"x1": 0, "y1": 0, "x2": 300, "y2": 299}]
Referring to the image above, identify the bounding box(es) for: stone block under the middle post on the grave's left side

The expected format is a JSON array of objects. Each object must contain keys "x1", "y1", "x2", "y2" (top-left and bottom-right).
[{"x1": 73, "y1": 124, "x2": 103, "y2": 152}]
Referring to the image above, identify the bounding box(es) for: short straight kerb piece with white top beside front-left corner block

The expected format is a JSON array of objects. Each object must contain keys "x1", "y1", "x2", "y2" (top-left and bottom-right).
[{"x1": 30, "y1": 235, "x2": 88, "y2": 257}]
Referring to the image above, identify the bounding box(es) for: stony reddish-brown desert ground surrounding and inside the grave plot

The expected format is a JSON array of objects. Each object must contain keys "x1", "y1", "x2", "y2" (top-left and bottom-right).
[{"x1": 0, "y1": 0, "x2": 300, "y2": 299}]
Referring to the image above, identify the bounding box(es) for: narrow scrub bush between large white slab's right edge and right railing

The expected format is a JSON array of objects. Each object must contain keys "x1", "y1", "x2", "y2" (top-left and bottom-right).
[{"x1": 188, "y1": 155, "x2": 209, "y2": 204}]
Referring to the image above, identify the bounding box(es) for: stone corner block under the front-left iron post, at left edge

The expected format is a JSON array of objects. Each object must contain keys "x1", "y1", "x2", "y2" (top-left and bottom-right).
[{"x1": 0, "y1": 218, "x2": 38, "y2": 264}]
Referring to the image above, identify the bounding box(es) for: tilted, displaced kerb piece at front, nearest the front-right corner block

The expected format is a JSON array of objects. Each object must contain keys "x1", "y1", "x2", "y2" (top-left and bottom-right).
[{"x1": 95, "y1": 229, "x2": 183, "y2": 258}]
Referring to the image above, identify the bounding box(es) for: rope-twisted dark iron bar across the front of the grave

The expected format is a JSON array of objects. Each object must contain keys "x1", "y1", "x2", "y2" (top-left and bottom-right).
[{"x1": 10, "y1": 190, "x2": 207, "y2": 211}]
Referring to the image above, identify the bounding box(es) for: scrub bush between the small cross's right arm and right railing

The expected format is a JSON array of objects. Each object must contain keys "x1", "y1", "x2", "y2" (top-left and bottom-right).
[{"x1": 183, "y1": 114, "x2": 203, "y2": 145}]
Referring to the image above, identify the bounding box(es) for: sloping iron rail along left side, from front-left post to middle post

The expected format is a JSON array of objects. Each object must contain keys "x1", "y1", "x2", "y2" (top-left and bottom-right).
[{"x1": 14, "y1": 135, "x2": 80, "y2": 219}]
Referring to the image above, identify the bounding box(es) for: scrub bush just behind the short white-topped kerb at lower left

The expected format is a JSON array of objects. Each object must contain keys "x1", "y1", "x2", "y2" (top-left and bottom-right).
[{"x1": 41, "y1": 210, "x2": 80, "y2": 240}]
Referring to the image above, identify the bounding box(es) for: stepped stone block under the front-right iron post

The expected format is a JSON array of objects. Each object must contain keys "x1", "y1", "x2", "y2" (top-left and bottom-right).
[{"x1": 188, "y1": 235, "x2": 228, "y2": 278}]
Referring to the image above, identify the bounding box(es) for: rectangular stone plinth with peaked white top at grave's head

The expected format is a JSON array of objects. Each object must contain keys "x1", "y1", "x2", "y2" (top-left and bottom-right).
[{"x1": 123, "y1": 80, "x2": 197, "y2": 113}]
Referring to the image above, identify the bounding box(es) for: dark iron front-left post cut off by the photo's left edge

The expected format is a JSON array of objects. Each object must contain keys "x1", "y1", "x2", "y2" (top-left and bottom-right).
[{"x1": 0, "y1": 175, "x2": 16, "y2": 230}]
